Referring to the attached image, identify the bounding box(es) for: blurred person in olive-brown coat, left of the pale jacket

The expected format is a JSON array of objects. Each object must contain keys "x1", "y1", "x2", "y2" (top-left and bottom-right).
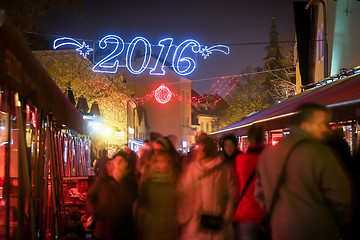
[{"x1": 136, "y1": 151, "x2": 179, "y2": 240}]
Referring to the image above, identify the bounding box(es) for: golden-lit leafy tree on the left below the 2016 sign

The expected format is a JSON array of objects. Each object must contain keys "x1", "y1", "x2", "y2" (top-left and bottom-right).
[{"x1": 34, "y1": 50, "x2": 132, "y2": 135}]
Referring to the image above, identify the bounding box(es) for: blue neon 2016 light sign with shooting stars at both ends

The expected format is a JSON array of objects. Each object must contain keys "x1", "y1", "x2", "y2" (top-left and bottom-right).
[{"x1": 53, "y1": 35, "x2": 230, "y2": 76}]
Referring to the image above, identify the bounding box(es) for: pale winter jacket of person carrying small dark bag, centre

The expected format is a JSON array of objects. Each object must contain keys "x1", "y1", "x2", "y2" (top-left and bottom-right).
[{"x1": 177, "y1": 158, "x2": 236, "y2": 240}]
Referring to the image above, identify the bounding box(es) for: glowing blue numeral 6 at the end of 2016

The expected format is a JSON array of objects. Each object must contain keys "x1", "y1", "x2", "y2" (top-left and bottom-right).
[{"x1": 172, "y1": 39, "x2": 201, "y2": 76}]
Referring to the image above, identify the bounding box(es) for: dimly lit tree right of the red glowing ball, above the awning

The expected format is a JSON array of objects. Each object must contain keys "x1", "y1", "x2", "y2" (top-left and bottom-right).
[{"x1": 214, "y1": 67, "x2": 269, "y2": 128}]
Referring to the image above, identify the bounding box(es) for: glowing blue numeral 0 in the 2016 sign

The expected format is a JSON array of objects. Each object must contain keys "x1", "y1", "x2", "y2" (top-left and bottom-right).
[{"x1": 126, "y1": 37, "x2": 151, "y2": 74}]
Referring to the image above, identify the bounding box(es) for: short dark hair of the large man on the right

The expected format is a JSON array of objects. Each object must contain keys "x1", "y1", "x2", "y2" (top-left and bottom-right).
[{"x1": 294, "y1": 102, "x2": 331, "y2": 125}]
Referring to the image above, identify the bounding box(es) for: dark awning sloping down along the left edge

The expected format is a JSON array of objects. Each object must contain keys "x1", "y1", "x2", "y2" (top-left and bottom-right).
[{"x1": 0, "y1": 10, "x2": 84, "y2": 133}]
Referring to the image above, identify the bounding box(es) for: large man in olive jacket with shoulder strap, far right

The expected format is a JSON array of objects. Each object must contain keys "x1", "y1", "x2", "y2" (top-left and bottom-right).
[{"x1": 255, "y1": 103, "x2": 351, "y2": 240}]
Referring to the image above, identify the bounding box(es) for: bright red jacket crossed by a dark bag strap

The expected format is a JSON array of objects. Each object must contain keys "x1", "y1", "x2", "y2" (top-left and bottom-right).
[{"x1": 233, "y1": 145, "x2": 265, "y2": 224}]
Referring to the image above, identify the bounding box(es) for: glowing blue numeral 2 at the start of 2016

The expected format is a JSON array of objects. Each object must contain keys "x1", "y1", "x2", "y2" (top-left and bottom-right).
[{"x1": 92, "y1": 35, "x2": 124, "y2": 73}]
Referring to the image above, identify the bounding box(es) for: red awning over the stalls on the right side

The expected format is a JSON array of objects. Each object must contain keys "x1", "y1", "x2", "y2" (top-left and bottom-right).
[{"x1": 212, "y1": 74, "x2": 360, "y2": 138}]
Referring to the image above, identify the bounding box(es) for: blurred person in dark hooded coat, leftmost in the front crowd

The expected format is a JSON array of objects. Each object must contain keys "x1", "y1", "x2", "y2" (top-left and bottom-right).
[{"x1": 86, "y1": 150, "x2": 137, "y2": 240}]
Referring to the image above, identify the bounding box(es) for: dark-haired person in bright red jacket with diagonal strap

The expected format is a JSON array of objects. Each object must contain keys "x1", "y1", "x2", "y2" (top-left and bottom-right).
[{"x1": 232, "y1": 125, "x2": 265, "y2": 240}]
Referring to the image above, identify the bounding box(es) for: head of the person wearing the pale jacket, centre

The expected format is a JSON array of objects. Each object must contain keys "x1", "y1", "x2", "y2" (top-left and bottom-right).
[{"x1": 196, "y1": 133, "x2": 218, "y2": 159}]
